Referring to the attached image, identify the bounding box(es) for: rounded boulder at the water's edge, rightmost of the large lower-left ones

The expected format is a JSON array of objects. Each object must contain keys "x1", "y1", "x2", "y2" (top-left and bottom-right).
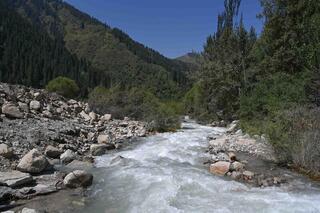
[{"x1": 63, "y1": 170, "x2": 93, "y2": 188}]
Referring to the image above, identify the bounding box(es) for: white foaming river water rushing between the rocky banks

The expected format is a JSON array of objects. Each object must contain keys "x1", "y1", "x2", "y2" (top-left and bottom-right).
[{"x1": 83, "y1": 123, "x2": 320, "y2": 213}]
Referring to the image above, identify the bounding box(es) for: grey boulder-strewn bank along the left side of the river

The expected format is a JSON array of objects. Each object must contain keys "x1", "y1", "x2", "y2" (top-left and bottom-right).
[{"x1": 0, "y1": 83, "x2": 148, "y2": 212}]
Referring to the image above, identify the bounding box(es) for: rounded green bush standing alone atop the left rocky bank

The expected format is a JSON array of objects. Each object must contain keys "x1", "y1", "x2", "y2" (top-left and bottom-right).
[{"x1": 46, "y1": 76, "x2": 80, "y2": 98}]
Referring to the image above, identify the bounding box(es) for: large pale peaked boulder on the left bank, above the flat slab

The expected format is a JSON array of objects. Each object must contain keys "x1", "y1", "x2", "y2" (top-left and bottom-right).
[{"x1": 17, "y1": 149, "x2": 49, "y2": 174}]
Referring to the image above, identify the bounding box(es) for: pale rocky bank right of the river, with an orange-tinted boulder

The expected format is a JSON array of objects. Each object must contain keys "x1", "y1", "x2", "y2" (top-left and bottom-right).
[{"x1": 206, "y1": 121, "x2": 290, "y2": 187}]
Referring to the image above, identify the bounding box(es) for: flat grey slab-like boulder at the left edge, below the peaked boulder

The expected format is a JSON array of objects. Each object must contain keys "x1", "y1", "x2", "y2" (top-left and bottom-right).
[{"x1": 0, "y1": 171, "x2": 33, "y2": 188}]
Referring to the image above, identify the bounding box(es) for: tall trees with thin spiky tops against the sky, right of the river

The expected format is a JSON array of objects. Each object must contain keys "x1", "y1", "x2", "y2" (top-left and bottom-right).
[{"x1": 187, "y1": 0, "x2": 256, "y2": 120}]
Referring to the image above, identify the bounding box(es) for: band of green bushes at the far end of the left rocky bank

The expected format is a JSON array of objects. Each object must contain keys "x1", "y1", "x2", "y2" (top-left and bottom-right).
[{"x1": 89, "y1": 86, "x2": 181, "y2": 131}]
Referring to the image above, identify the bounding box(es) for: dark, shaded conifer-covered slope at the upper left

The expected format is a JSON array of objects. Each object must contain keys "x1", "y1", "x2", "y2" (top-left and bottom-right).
[{"x1": 0, "y1": 2, "x2": 95, "y2": 95}]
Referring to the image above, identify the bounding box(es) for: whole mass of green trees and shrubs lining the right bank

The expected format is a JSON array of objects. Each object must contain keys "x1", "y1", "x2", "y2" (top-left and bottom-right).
[{"x1": 185, "y1": 0, "x2": 320, "y2": 176}]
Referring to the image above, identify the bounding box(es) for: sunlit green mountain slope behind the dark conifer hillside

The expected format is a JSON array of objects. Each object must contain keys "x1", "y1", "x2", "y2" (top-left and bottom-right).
[{"x1": 3, "y1": 0, "x2": 192, "y2": 98}]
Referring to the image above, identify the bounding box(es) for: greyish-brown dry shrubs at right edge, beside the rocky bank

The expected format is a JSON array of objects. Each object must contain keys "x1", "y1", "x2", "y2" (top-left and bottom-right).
[{"x1": 241, "y1": 106, "x2": 320, "y2": 175}]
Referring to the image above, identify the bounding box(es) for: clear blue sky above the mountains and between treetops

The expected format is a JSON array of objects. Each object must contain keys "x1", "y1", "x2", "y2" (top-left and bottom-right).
[{"x1": 65, "y1": 0, "x2": 262, "y2": 58}]
